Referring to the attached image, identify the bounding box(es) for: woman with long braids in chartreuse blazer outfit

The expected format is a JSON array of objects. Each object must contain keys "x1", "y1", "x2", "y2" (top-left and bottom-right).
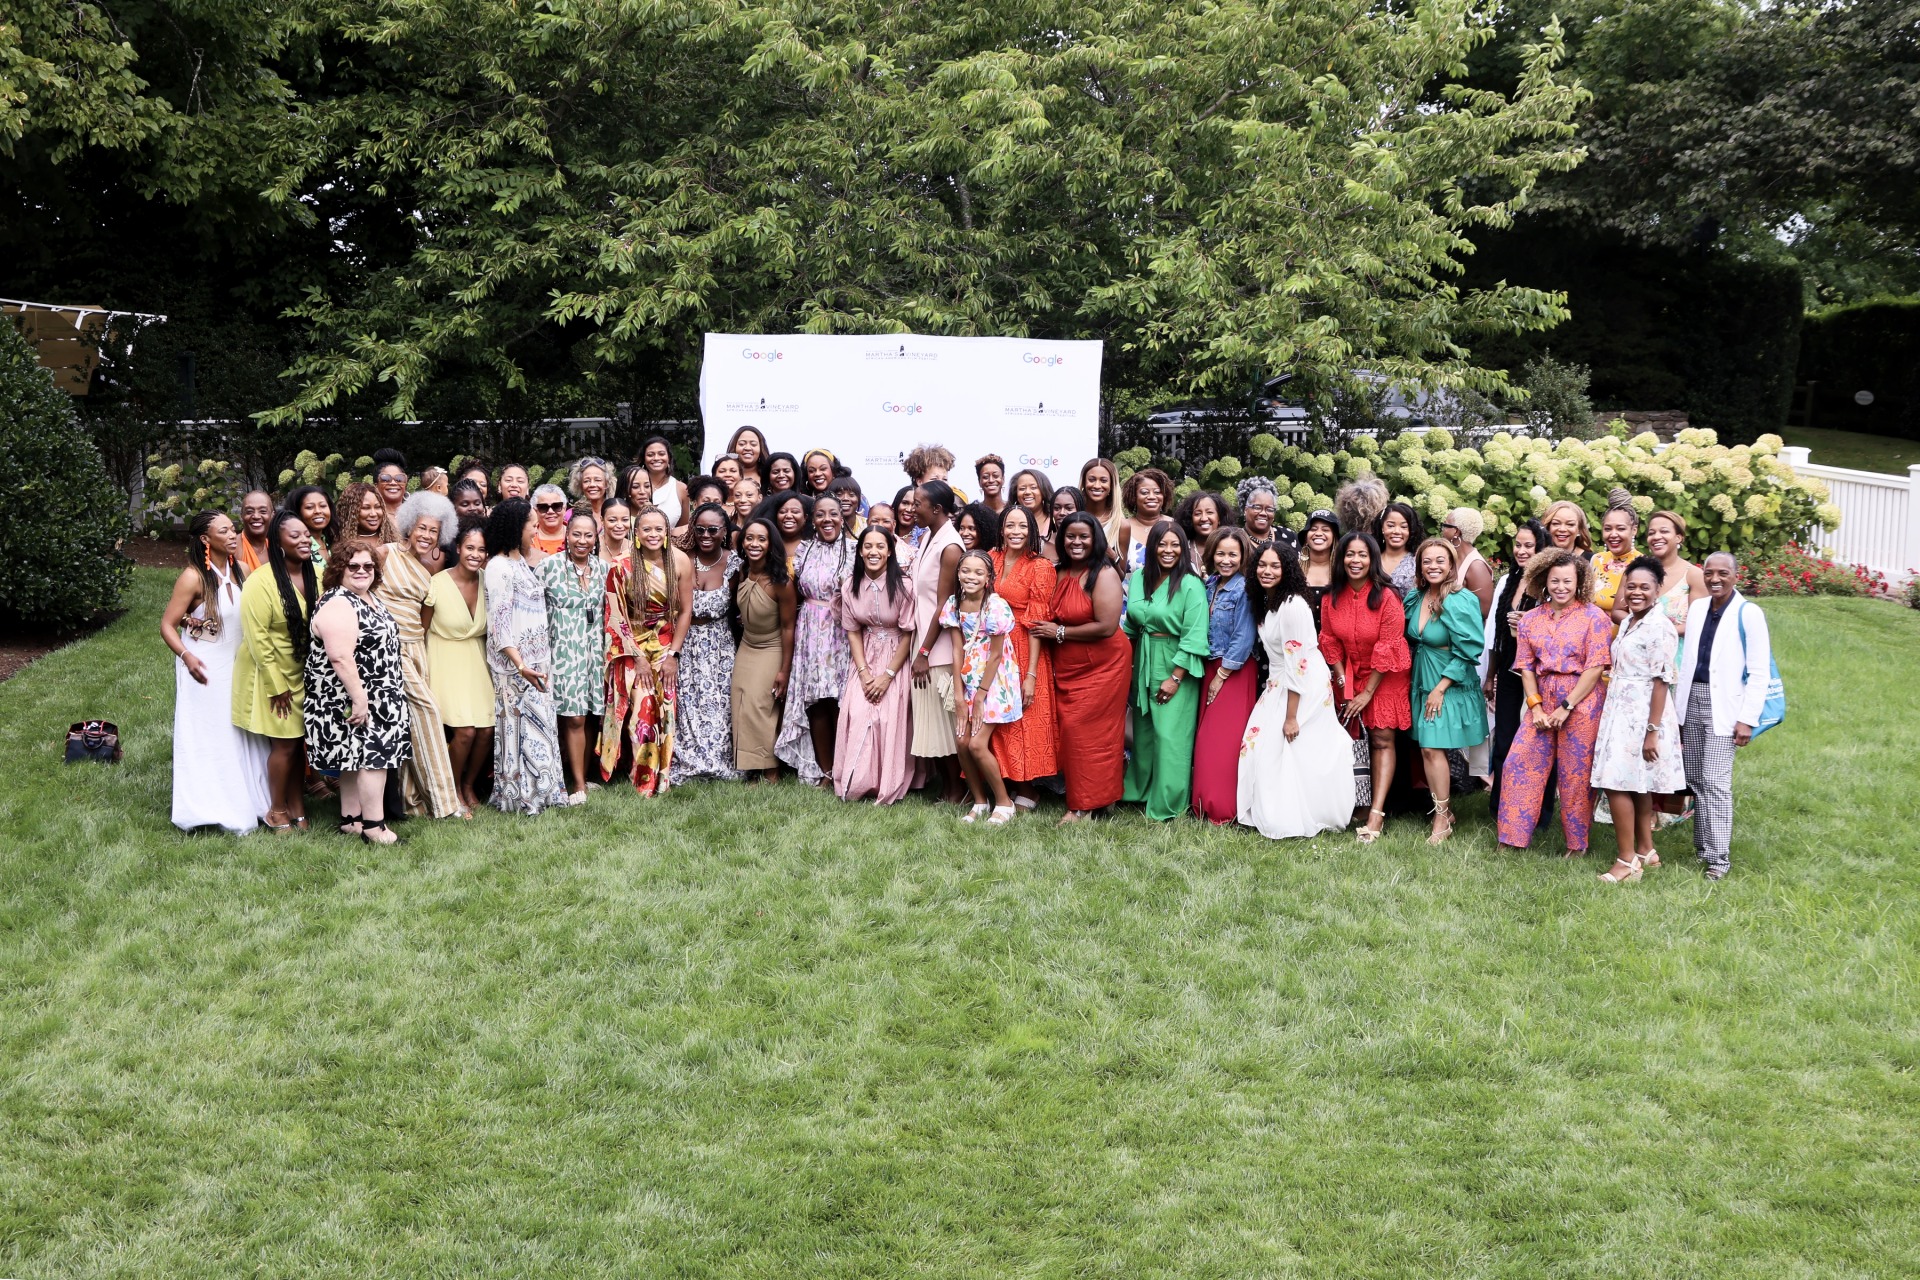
[{"x1": 232, "y1": 497, "x2": 314, "y2": 831}]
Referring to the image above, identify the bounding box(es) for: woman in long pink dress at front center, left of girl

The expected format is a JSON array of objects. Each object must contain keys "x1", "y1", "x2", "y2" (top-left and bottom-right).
[{"x1": 833, "y1": 526, "x2": 914, "y2": 804}]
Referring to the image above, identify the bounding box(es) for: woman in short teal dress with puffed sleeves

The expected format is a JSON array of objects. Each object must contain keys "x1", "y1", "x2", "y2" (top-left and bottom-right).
[{"x1": 1407, "y1": 537, "x2": 1486, "y2": 844}]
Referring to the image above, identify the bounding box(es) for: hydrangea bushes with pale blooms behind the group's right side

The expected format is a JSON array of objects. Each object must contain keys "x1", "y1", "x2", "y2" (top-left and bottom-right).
[{"x1": 1182, "y1": 424, "x2": 1839, "y2": 560}]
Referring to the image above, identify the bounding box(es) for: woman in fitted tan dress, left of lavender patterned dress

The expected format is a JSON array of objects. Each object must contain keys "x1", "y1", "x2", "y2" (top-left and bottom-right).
[{"x1": 732, "y1": 516, "x2": 797, "y2": 783}]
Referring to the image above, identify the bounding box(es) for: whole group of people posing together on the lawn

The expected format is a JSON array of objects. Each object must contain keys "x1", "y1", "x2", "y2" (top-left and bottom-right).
[{"x1": 161, "y1": 428, "x2": 1768, "y2": 883}]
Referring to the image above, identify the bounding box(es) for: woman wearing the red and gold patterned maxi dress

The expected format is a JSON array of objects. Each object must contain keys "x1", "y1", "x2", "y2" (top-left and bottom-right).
[{"x1": 599, "y1": 505, "x2": 693, "y2": 796}]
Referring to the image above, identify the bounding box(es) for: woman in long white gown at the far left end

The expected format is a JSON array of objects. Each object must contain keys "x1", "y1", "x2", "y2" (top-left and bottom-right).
[{"x1": 159, "y1": 510, "x2": 273, "y2": 835}]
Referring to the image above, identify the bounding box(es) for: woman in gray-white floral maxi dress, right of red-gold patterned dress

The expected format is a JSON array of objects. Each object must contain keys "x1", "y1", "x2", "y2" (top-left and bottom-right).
[{"x1": 668, "y1": 503, "x2": 739, "y2": 787}]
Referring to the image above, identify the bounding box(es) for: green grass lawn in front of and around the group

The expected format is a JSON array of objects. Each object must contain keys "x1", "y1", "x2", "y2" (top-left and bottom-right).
[{"x1": 0, "y1": 570, "x2": 1920, "y2": 1280}]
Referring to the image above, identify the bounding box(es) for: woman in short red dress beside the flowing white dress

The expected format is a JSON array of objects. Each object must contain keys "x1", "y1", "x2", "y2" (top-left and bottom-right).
[{"x1": 1321, "y1": 530, "x2": 1413, "y2": 844}]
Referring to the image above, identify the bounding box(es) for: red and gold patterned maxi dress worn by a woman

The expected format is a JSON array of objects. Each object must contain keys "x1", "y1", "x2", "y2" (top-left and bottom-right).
[{"x1": 599, "y1": 547, "x2": 676, "y2": 796}]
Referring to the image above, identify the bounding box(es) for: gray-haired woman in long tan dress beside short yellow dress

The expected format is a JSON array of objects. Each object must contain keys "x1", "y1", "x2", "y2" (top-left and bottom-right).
[{"x1": 374, "y1": 489, "x2": 472, "y2": 818}]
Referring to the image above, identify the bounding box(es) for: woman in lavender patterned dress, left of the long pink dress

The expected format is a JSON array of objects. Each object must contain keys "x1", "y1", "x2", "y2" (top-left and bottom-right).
[{"x1": 774, "y1": 495, "x2": 856, "y2": 787}]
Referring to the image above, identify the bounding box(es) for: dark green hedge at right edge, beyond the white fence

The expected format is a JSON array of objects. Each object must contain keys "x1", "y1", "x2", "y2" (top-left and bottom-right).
[{"x1": 1799, "y1": 297, "x2": 1920, "y2": 439}]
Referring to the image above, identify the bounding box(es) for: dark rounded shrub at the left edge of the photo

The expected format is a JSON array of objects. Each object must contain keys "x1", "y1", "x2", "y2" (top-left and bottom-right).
[{"x1": 0, "y1": 324, "x2": 132, "y2": 626}]
